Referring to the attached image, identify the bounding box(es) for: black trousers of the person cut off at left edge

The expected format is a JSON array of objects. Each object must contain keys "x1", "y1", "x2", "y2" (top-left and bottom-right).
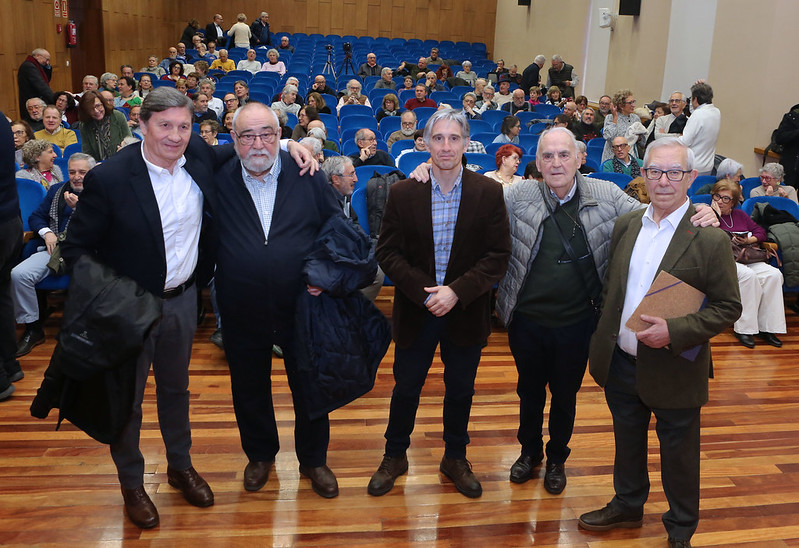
[{"x1": 0, "y1": 215, "x2": 22, "y2": 387}]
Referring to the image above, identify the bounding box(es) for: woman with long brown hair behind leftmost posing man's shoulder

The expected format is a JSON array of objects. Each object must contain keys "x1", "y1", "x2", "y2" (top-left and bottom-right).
[{"x1": 79, "y1": 91, "x2": 131, "y2": 162}]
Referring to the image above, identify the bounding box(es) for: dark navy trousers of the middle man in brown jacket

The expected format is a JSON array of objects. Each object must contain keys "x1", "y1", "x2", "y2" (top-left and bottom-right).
[{"x1": 385, "y1": 315, "x2": 482, "y2": 459}]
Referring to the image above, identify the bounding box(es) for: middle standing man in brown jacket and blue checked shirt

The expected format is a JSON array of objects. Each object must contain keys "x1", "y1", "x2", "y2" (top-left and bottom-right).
[{"x1": 368, "y1": 109, "x2": 510, "y2": 497}]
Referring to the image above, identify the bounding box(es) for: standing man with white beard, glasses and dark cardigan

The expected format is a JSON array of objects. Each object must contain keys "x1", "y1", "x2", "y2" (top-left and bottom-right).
[{"x1": 214, "y1": 102, "x2": 343, "y2": 498}]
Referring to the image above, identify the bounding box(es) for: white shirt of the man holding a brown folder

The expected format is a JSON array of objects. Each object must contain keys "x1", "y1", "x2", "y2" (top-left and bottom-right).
[{"x1": 617, "y1": 198, "x2": 691, "y2": 356}]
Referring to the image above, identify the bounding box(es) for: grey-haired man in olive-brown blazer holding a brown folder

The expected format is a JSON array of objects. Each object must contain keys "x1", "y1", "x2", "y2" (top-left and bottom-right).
[{"x1": 579, "y1": 139, "x2": 741, "y2": 546}]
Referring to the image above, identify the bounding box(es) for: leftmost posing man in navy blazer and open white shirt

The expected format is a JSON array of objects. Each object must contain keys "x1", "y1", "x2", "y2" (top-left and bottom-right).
[{"x1": 62, "y1": 87, "x2": 215, "y2": 528}]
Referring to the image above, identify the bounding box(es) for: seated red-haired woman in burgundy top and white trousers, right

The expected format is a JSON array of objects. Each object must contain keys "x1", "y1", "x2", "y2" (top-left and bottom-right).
[{"x1": 712, "y1": 179, "x2": 786, "y2": 348}]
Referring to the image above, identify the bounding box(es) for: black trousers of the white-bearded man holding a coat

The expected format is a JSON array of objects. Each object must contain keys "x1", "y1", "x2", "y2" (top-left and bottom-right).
[{"x1": 222, "y1": 322, "x2": 330, "y2": 468}]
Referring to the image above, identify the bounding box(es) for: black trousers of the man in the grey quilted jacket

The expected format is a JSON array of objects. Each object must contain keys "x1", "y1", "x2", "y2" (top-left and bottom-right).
[{"x1": 508, "y1": 313, "x2": 593, "y2": 464}]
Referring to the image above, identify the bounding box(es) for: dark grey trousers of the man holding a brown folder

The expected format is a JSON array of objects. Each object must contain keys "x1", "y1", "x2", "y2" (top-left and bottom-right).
[{"x1": 605, "y1": 349, "x2": 701, "y2": 539}]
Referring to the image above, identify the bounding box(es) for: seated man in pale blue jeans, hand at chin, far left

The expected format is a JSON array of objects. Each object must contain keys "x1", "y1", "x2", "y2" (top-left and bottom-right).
[{"x1": 11, "y1": 154, "x2": 96, "y2": 358}]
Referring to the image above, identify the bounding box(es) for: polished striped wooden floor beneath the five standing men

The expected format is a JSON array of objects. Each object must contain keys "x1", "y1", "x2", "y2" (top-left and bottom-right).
[{"x1": 0, "y1": 288, "x2": 799, "y2": 547}]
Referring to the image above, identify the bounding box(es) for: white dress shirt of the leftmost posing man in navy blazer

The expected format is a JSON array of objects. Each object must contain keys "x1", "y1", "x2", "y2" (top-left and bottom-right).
[{"x1": 141, "y1": 147, "x2": 203, "y2": 290}]
